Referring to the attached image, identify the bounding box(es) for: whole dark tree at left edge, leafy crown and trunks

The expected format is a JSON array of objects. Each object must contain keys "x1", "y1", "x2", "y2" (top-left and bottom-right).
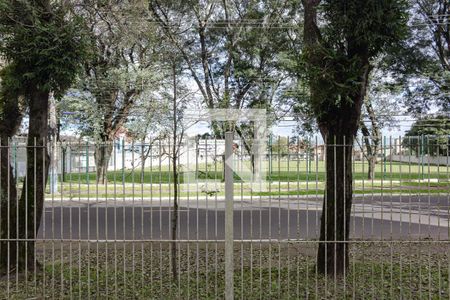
[{"x1": 0, "y1": 0, "x2": 86, "y2": 272}]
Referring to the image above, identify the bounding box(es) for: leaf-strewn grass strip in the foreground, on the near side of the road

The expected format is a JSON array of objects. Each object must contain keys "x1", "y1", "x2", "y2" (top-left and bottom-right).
[{"x1": 0, "y1": 242, "x2": 450, "y2": 299}]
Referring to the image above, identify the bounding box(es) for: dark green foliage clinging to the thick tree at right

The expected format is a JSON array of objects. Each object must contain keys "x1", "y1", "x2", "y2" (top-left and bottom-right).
[{"x1": 299, "y1": 0, "x2": 408, "y2": 118}]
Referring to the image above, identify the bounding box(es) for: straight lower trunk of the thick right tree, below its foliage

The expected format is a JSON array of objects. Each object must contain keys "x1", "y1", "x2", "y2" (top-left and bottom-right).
[{"x1": 317, "y1": 135, "x2": 353, "y2": 276}]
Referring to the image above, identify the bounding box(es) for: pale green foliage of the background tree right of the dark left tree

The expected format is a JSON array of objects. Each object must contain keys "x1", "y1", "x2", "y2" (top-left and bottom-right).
[{"x1": 65, "y1": 0, "x2": 159, "y2": 140}]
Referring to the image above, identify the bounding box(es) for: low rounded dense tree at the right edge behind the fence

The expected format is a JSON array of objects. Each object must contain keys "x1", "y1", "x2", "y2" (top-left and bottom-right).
[{"x1": 402, "y1": 115, "x2": 450, "y2": 156}]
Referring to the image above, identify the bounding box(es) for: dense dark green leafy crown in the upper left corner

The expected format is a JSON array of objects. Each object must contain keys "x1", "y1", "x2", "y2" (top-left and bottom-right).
[{"x1": 0, "y1": 0, "x2": 87, "y2": 98}]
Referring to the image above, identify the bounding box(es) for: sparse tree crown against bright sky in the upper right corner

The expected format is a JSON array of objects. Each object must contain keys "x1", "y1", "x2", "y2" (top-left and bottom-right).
[{"x1": 389, "y1": 0, "x2": 450, "y2": 115}]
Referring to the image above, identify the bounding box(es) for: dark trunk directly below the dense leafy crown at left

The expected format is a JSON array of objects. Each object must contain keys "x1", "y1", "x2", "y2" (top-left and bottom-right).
[{"x1": 18, "y1": 90, "x2": 50, "y2": 271}]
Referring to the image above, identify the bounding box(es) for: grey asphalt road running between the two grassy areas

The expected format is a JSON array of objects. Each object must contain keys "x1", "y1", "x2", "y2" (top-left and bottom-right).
[{"x1": 39, "y1": 195, "x2": 449, "y2": 240}]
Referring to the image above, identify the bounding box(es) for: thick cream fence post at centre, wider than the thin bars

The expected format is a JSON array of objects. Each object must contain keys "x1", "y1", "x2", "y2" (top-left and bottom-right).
[{"x1": 224, "y1": 132, "x2": 234, "y2": 300}]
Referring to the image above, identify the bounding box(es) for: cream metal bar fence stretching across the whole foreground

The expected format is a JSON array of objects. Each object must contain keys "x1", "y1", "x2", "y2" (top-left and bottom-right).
[{"x1": 0, "y1": 136, "x2": 450, "y2": 299}]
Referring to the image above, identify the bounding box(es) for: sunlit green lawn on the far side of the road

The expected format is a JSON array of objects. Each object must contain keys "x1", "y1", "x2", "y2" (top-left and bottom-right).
[{"x1": 43, "y1": 161, "x2": 450, "y2": 200}]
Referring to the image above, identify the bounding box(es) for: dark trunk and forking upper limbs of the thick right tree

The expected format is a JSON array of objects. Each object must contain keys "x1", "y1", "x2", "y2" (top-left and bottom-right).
[{"x1": 302, "y1": 0, "x2": 370, "y2": 277}]
